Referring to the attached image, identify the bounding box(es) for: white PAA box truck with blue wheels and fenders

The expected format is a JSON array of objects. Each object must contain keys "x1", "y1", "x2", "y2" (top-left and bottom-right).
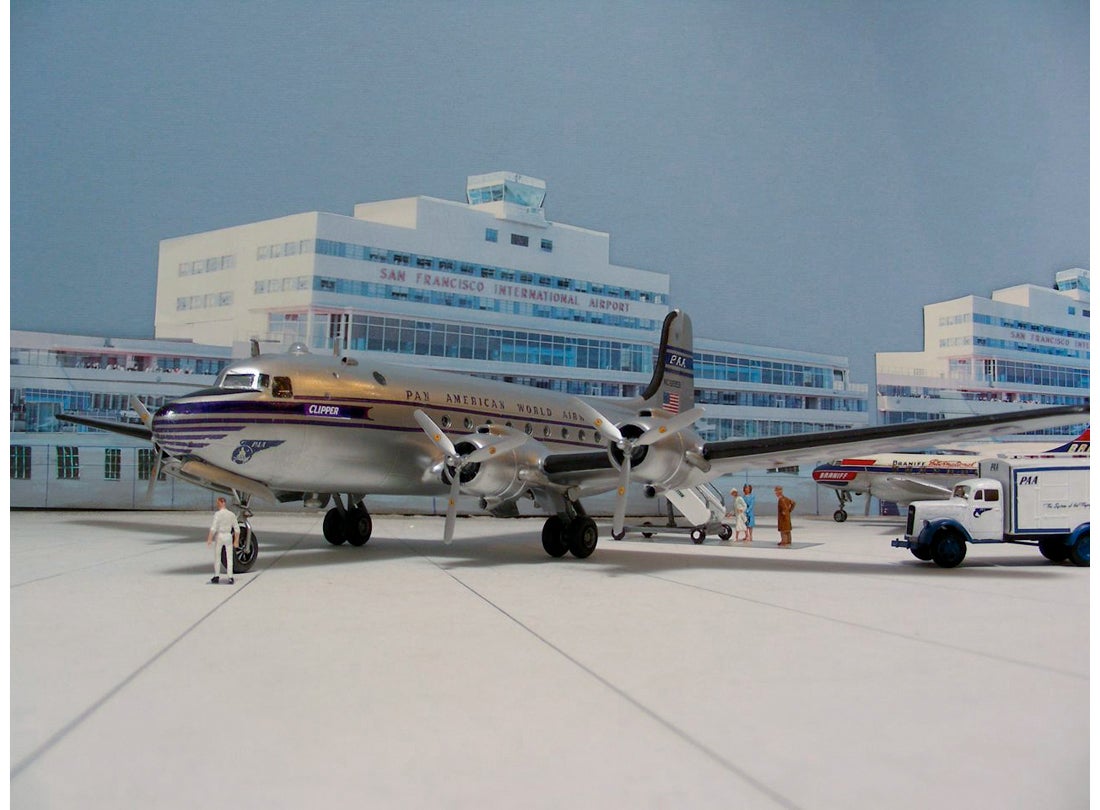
[{"x1": 891, "y1": 457, "x2": 1089, "y2": 568}]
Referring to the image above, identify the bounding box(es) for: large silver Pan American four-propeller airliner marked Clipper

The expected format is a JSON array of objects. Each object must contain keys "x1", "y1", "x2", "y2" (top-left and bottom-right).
[{"x1": 58, "y1": 310, "x2": 1088, "y2": 571}]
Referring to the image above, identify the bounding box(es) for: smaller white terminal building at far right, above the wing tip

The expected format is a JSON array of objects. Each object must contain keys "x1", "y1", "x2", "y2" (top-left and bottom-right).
[{"x1": 876, "y1": 267, "x2": 1090, "y2": 428}]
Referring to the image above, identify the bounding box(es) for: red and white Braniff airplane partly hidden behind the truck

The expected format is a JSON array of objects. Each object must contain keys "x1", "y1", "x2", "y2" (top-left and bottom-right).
[{"x1": 813, "y1": 428, "x2": 1089, "y2": 523}]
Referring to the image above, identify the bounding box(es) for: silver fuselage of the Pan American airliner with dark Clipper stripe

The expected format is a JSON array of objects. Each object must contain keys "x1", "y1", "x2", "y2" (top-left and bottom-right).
[{"x1": 153, "y1": 354, "x2": 633, "y2": 495}]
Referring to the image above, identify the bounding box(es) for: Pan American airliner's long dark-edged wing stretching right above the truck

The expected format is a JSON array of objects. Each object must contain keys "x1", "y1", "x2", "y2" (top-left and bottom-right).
[{"x1": 543, "y1": 405, "x2": 1089, "y2": 491}]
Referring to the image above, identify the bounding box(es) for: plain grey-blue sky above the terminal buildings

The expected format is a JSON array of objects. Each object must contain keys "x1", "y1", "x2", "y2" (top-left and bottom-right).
[{"x1": 11, "y1": 0, "x2": 1089, "y2": 383}]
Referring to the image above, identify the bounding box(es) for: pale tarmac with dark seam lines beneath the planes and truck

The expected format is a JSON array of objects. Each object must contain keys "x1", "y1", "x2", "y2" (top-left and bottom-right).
[{"x1": 11, "y1": 512, "x2": 1089, "y2": 810}]
